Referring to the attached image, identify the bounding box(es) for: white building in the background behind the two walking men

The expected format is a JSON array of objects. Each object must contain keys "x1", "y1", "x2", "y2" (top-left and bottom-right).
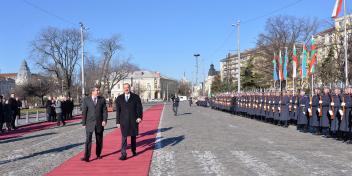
[{"x1": 111, "y1": 71, "x2": 178, "y2": 102}]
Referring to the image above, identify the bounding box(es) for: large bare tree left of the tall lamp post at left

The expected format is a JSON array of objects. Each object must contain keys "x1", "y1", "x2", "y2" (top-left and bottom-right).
[{"x1": 31, "y1": 27, "x2": 81, "y2": 96}]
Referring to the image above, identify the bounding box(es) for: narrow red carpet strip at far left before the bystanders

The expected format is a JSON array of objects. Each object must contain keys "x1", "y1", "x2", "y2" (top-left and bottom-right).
[{"x1": 0, "y1": 115, "x2": 82, "y2": 141}]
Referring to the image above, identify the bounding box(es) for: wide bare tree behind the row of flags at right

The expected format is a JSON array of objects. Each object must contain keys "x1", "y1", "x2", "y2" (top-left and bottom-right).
[{"x1": 257, "y1": 16, "x2": 319, "y2": 89}]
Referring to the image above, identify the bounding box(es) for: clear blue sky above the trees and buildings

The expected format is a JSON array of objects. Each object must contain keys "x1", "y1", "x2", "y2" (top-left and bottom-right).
[{"x1": 0, "y1": 0, "x2": 344, "y2": 81}]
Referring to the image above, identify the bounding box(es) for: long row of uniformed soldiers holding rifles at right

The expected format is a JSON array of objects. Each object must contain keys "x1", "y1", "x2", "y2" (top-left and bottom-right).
[{"x1": 203, "y1": 87, "x2": 352, "y2": 143}]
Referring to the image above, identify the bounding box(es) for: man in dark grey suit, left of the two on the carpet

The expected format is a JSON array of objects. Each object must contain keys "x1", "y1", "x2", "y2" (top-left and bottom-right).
[{"x1": 81, "y1": 86, "x2": 108, "y2": 162}]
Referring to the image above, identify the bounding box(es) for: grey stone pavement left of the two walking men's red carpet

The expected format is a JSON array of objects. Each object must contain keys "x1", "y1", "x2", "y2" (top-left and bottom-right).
[{"x1": 0, "y1": 104, "x2": 153, "y2": 176}]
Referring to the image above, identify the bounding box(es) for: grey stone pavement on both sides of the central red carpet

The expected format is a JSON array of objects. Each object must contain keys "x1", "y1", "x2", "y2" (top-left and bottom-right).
[{"x1": 0, "y1": 102, "x2": 352, "y2": 176}]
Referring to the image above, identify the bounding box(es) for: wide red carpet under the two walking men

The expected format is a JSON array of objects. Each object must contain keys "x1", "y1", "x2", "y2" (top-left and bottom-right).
[{"x1": 47, "y1": 104, "x2": 164, "y2": 176}]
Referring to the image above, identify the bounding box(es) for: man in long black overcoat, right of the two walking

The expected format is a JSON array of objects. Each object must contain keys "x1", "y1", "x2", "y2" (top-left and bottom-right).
[{"x1": 115, "y1": 83, "x2": 143, "y2": 160}]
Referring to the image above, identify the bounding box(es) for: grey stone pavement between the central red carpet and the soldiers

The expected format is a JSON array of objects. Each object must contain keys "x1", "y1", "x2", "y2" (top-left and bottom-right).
[{"x1": 149, "y1": 102, "x2": 352, "y2": 176}]
